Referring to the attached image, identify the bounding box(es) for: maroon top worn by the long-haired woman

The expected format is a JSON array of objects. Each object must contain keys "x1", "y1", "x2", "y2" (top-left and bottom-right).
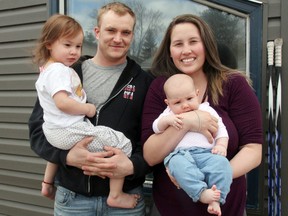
[{"x1": 142, "y1": 75, "x2": 263, "y2": 216}]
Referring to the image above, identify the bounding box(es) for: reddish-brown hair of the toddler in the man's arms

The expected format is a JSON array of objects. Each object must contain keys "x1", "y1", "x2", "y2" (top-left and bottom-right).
[{"x1": 33, "y1": 14, "x2": 84, "y2": 66}]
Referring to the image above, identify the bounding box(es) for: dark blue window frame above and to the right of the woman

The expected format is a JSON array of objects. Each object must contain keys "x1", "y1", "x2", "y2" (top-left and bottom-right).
[{"x1": 201, "y1": 0, "x2": 263, "y2": 215}]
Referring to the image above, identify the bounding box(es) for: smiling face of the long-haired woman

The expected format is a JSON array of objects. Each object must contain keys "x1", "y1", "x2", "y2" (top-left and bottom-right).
[{"x1": 170, "y1": 23, "x2": 205, "y2": 76}]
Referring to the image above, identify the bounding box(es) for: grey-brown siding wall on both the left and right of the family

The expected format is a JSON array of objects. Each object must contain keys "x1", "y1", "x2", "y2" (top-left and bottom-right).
[{"x1": 0, "y1": 0, "x2": 288, "y2": 216}]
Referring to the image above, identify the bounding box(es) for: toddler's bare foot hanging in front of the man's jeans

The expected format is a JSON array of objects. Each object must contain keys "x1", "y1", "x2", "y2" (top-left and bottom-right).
[{"x1": 107, "y1": 193, "x2": 140, "y2": 208}]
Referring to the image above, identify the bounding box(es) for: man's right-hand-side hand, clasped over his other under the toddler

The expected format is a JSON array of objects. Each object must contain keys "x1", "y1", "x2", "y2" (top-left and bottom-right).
[{"x1": 82, "y1": 146, "x2": 134, "y2": 178}]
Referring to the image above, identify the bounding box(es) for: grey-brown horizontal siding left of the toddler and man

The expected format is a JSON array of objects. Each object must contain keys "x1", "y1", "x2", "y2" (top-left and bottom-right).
[{"x1": 0, "y1": 0, "x2": 53, "y2": 216}]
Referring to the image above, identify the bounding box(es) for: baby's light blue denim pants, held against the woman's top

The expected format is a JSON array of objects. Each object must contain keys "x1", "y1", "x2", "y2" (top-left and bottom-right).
[{"x1": 164, "y1": 147, "x2": 232, "y2": 204}]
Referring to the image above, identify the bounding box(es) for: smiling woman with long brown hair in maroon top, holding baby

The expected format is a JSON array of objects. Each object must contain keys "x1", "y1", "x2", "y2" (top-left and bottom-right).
[{"x1": 142, "y1": 14, "x2": 263, "y2": 216}]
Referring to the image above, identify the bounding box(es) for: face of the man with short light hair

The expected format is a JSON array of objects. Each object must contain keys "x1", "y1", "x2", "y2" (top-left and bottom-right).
[{"x1": 95, "y1": 11, "x2": 135, "y2": 65}]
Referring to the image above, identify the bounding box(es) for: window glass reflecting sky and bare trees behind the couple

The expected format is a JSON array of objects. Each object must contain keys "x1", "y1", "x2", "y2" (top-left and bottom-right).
[{"x1": 67, "y1": 0, "x2": 249, "y2": 71}]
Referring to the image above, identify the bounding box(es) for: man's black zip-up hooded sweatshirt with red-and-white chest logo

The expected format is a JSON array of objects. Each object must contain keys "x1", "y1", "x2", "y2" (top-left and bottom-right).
[{"x1": 29, "y1": 56, "x2": 153, "y2": 196}]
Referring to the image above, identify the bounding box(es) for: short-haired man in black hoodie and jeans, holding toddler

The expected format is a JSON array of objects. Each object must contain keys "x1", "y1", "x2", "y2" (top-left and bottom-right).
[{"x1": 29, "y1": 2, "x2": 152, "y2": 216}]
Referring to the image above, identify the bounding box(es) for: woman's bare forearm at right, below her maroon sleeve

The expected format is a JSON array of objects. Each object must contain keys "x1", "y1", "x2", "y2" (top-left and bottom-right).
[{"x1": 230, "y1": 143, "x2": 262, "y2": 178}]
